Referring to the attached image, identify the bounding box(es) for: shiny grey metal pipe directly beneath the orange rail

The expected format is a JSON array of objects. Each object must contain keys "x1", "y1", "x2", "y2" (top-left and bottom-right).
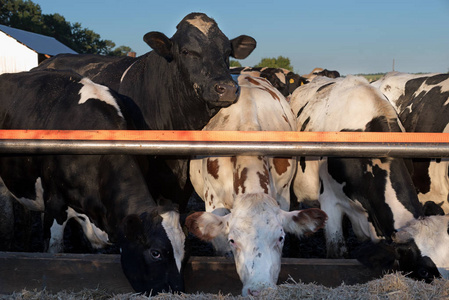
[{"x1": 0, "y1": 139, "x2": 449, "y2": 158}]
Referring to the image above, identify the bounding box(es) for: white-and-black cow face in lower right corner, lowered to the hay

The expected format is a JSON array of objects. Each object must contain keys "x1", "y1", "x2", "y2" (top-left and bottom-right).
[{"x1": 392, "y1": 215, "x2": 449, "y2": 282}]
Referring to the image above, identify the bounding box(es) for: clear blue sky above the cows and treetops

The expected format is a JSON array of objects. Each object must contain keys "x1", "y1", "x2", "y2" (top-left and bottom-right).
[{"x1": 33, "y1": 0, "x2": 449, "y2": 75}]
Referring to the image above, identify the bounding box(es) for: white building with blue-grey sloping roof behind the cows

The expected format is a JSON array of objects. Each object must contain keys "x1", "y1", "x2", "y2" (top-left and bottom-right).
[{"x1": 0, "y1": 25, "x2": 77, "y2": 74}]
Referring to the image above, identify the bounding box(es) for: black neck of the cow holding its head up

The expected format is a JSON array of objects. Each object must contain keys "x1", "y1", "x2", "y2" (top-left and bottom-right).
[{"x1": 120, "y1": 51, "x2": 218, "y2": 130}]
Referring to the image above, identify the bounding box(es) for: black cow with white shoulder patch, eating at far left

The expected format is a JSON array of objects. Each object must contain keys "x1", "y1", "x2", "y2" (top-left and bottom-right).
[{"x1": 0, "y1": 70, "x2": 185, "y2": 293}]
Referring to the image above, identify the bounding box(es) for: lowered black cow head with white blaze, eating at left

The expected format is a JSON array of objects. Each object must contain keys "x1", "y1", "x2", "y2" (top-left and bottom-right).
[{"x1": 120, "y1": 208, "x2": 185, "y2": 295}]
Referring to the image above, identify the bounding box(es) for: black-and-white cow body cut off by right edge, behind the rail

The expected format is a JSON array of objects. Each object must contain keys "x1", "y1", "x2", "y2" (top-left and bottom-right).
[{"x1": 372, "y1": 72, "x2": 449, "y2": 214}]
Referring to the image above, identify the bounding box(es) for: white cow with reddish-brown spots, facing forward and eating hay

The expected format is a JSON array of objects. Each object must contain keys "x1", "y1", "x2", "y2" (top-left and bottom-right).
[{"x1": 186, "y1": 75, "x2": 326, "y2": 296}]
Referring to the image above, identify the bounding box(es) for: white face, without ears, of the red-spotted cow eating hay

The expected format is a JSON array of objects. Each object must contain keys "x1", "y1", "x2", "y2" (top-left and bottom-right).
[{"x1": 228, "y1": 194, "x2": 285, "y2": 296}]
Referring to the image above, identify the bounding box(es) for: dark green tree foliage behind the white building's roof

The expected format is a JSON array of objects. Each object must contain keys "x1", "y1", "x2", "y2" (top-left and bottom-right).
[{"x1": 0, "y1": 0, "x2": 131, "y2": 56}]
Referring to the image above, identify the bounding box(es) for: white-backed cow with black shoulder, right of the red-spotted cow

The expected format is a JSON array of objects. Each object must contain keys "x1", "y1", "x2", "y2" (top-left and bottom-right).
[{"x1": 290, "y1": 76, "x2": 444, "y2": 280}]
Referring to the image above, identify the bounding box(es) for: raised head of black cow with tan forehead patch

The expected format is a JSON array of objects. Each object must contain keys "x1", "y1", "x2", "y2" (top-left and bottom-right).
[{"x1": 144, "y1": 13, "x2": 256, "y2": 108}]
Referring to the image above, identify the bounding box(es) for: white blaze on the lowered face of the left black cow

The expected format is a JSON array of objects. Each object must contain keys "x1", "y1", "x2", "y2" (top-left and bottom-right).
[{"x1": 161, "y1": 211, "x2": 185, "y2": 272}]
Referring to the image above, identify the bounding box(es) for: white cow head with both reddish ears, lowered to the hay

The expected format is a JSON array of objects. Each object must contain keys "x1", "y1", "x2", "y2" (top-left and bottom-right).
[{"x1": 186, "y1": 193, "x2": 327, "y2": 296}]
